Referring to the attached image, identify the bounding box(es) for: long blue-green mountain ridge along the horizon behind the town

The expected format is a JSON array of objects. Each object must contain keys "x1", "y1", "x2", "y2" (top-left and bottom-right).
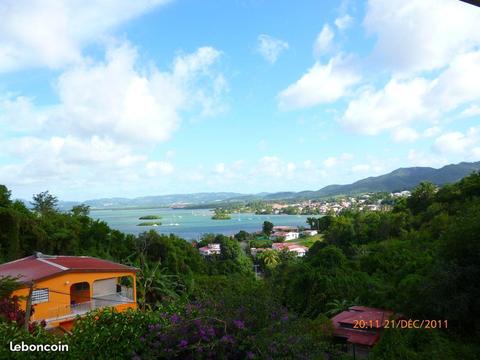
[{"x1": 60, "y1": 161, "x2": 480, "y2": 210}]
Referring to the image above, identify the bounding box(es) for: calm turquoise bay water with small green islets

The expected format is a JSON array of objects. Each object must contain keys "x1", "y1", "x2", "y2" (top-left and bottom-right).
[{"x1": 90, "y1": 208, "x2": 308, "y2": 239}]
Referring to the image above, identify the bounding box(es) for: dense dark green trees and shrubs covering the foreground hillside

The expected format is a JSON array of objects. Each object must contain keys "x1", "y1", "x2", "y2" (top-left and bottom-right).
[{"x1": 0, "y1": 173, "x2": 480, "y2": 359}]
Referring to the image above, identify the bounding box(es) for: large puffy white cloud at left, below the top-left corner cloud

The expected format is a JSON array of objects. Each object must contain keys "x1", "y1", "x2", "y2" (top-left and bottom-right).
[{"x1": 0, "y1": 44, "x2": 225, "y2": 144}]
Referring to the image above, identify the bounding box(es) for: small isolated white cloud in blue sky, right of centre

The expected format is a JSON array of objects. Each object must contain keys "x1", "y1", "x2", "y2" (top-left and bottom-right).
[{"x1": 278, "y1": 55, "x2": 360, "y2": 110}]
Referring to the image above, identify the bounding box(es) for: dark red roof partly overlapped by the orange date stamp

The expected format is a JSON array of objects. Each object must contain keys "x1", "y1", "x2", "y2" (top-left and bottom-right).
[{"x1": 332, "y1": 306, "x2": 394, "y2": 346}]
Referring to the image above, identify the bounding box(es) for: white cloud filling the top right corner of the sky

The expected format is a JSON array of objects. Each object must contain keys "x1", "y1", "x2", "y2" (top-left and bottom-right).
[{"x1": 364, "y1": 0, "x2": 480, "y2": 74}]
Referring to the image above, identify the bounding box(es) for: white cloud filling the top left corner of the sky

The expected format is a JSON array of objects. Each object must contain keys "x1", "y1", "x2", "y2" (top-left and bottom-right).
[{"x1": 0, "y1": 0, "x2": 172, "y2": 72}]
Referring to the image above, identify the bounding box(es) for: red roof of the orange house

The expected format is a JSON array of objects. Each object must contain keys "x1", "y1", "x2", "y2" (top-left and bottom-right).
[{"x1": 0, "y1": 253, "x2": 137, "y2": 283}]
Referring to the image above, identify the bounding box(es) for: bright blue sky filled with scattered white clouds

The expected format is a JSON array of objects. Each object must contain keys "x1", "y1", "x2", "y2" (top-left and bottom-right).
[{"x1": 0, "y1": 0, "x2": 480, "y2": 200}]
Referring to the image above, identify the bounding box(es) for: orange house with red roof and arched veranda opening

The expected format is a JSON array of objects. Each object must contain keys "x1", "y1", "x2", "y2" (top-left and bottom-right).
[{"x1": 0, "y1": 253, "x2": 137, "y2": 330}]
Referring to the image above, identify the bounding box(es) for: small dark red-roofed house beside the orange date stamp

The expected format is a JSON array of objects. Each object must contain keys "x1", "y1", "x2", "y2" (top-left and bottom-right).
[{"x1": 332, "y1": 306, "x2": 394, "y2": 357}]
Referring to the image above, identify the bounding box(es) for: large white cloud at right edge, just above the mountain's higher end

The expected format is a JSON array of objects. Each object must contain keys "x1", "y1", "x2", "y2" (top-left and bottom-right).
[{"x1": 340, "y1": 51, "x2": 480, "y2": 141}]
